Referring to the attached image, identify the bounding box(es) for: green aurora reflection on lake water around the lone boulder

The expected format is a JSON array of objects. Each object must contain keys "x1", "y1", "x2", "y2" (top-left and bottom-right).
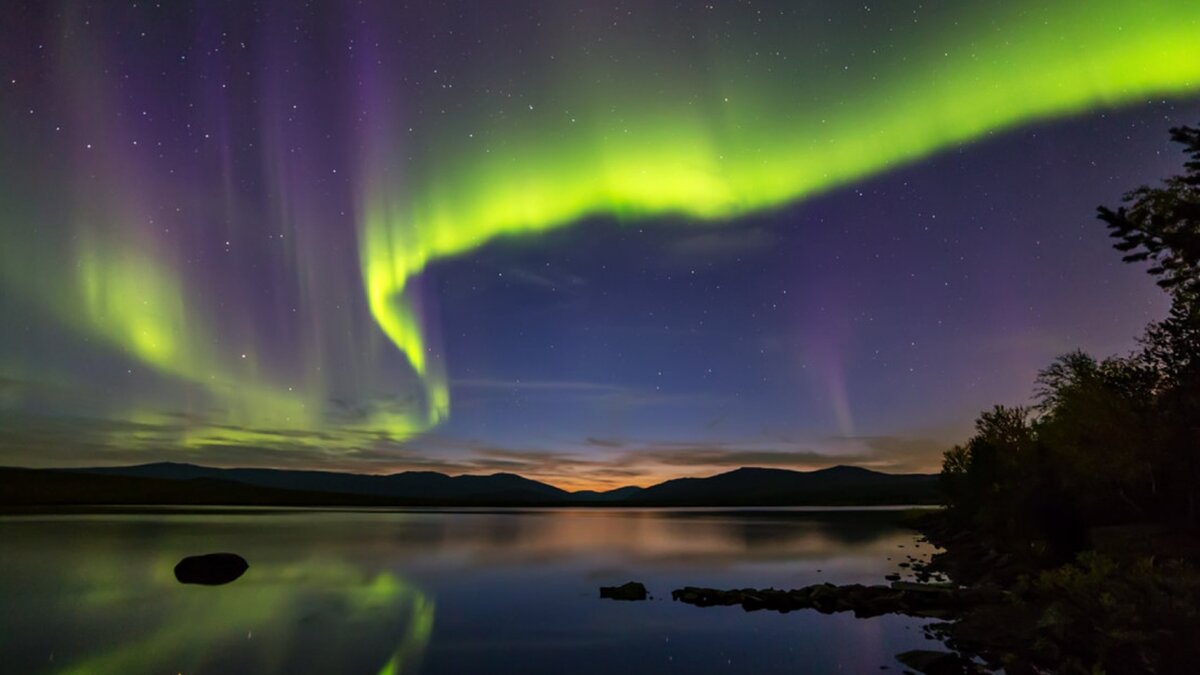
[{"x1": 0, "y1": 526, "x2": 434, "y2": 675}]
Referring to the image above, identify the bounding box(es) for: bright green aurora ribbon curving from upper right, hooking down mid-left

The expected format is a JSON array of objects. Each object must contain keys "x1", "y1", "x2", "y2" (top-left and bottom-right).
[{"x1": 361, "y1": 1, "x2": 1200, "y2": 439}]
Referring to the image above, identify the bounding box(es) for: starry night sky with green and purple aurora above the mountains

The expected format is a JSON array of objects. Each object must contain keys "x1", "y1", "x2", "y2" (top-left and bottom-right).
[{"x1": 0, "y1": 0, "x2": 1200, "y2": 489}]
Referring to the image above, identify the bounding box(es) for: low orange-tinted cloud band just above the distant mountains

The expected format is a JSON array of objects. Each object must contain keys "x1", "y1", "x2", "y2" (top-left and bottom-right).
[{"x1": 0, "y1": 401, "x2": 950, "y2": 490}]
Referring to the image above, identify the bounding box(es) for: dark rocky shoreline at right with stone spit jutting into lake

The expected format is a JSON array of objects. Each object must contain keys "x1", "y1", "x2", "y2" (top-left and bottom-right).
[{"x1": 608, "y1": 513, "x2": 1200, "y2": 675}]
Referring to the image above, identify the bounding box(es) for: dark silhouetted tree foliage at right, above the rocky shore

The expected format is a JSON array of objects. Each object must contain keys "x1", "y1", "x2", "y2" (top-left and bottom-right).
[{"x1": 942, "y1": 127, "x2": 1200, "y2": 535}]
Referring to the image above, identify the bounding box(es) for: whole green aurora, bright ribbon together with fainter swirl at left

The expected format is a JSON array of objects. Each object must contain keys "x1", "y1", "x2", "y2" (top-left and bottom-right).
[{"x1": 0, "y1": 0, "x2": 1200, "y2": 453}]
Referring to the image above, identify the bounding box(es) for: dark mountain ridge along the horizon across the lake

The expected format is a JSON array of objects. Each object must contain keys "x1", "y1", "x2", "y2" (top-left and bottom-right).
[{"x1": 0, "y1": 462, "x2": 937, "y2": 507}]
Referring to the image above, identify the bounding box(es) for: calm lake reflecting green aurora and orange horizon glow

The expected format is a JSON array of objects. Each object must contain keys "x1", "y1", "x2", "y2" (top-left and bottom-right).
[{"x1": 0, "y1": 509, "x2": 937, "y2": 675}]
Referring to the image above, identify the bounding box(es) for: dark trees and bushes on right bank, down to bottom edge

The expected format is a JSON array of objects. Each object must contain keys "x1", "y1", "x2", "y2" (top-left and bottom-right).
[{"x1": 941, "y1": 127, "x2": 1200, "y2": 673}]
